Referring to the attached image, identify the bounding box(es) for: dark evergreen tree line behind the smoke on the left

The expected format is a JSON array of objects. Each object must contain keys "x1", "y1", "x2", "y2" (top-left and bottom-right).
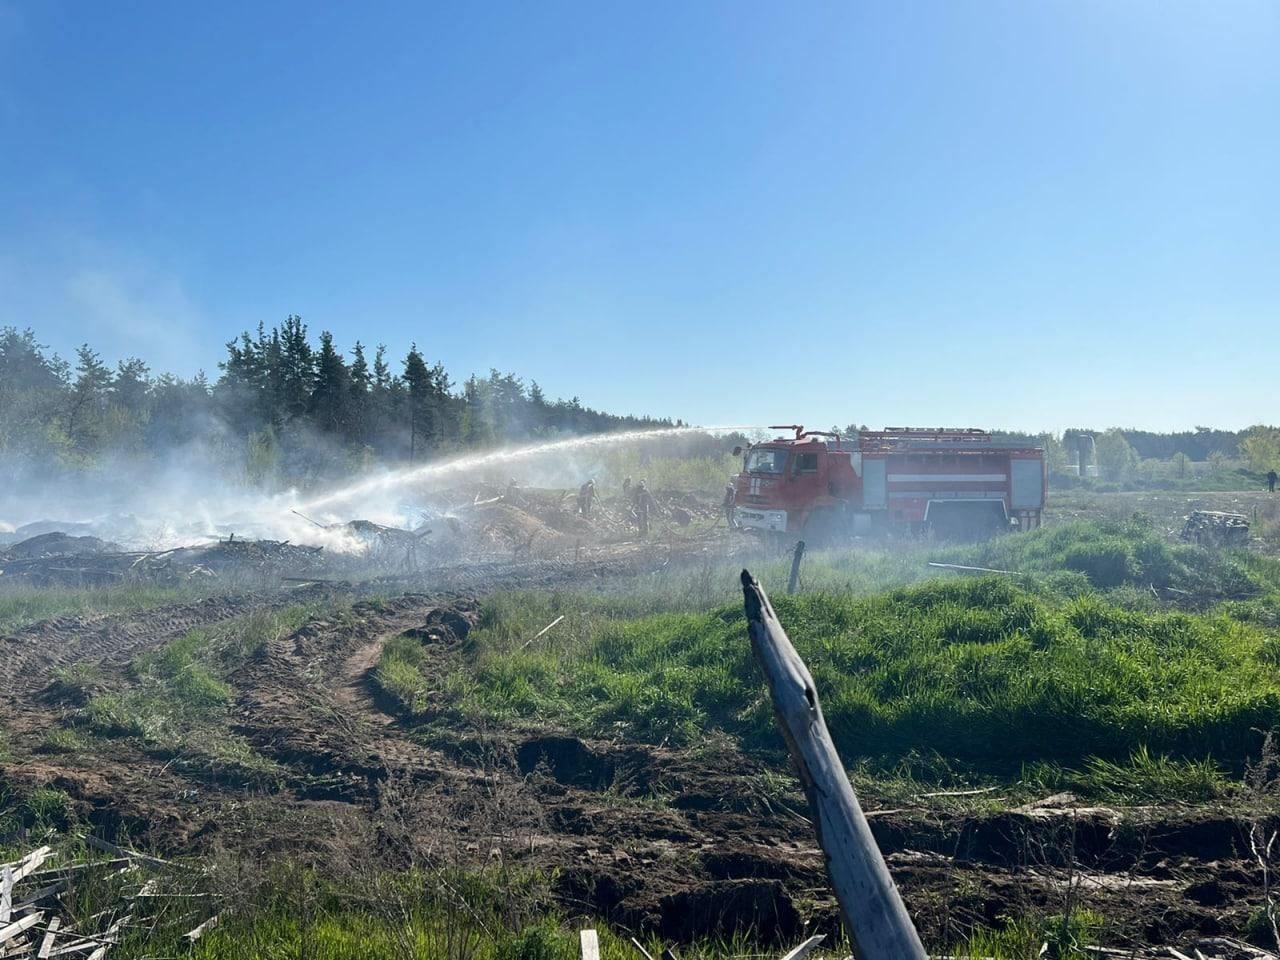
[{"x1": 0, "y1": 323, "x2": 673, "y2": 483}]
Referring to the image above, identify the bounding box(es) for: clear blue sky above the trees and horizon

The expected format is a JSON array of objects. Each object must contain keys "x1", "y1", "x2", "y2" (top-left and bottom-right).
[{"x1": 0, "y1": 0, "x2": 1280, "y2": 429}]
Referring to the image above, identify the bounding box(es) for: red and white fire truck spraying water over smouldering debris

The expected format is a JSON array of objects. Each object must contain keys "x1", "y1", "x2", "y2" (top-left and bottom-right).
[{"x1": 733, "y1": 425, "x2": 1047, "y2": 541}]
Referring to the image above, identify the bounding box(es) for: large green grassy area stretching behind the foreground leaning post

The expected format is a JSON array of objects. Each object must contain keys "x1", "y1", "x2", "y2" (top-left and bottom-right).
[{"x1": 379, "y1": 518, "x2": 1280, "y2": 796}]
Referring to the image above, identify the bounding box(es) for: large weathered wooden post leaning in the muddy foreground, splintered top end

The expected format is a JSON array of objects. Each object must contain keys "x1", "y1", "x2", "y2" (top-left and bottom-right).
[{"x1": 742, "y1": 570, "x2": 927, "y2": 960}]
